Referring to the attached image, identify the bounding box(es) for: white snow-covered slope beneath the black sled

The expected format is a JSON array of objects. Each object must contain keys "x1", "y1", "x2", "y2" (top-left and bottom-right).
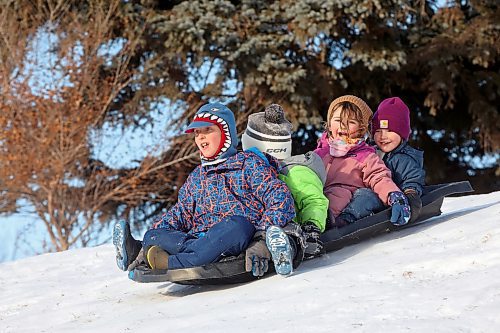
[{"x1": 0, "y1": 192, "x2": 500, "y2": 333}]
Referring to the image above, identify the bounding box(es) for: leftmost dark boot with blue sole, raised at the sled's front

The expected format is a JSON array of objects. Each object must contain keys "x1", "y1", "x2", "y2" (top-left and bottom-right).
[{"x1": 113, "y1": 221, "x2": 142, "y2": 271}]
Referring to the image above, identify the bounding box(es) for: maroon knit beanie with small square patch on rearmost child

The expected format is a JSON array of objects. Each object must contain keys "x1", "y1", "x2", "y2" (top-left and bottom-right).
[{"x1": 372, "y1": 97, "x2": 411, "y2": 140}]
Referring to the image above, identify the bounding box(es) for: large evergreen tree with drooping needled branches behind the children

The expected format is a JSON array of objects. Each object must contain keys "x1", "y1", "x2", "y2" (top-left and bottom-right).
[{"x1": 114, "y1": 0, "x2": 500, "y2": 191}]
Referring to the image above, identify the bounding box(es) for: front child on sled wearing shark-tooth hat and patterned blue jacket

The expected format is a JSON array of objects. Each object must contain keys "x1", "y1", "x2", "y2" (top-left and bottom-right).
[{"x1": 113, "y1": 103, "x2": 295, "y2": 275}]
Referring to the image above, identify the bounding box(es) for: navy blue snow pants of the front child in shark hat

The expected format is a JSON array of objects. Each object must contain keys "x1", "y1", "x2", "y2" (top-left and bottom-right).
[{"x1": 142, "y1": 215, "x2": 255, "y2": 269}]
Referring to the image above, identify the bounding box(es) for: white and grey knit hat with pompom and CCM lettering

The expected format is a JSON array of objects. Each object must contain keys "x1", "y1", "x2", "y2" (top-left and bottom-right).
[{"x1": 241, "y1": 104, "x2": 292, "y2": 160}]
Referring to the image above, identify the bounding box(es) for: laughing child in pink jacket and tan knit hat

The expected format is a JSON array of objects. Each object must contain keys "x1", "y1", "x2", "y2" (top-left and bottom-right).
[{"x1": 315, "y1": 95, "x2": 410, "y2": 227}]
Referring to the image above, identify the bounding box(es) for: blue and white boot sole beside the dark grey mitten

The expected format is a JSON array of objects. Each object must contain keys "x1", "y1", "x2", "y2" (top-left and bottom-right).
[{"x1": 266, "y1": 226, "x2": 293, "y2": 276}]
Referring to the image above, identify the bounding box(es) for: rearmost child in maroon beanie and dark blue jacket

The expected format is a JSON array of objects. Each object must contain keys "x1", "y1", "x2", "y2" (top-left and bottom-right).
[{"x1": 371, "y1": 97, "x2": 425, "y2": 221}]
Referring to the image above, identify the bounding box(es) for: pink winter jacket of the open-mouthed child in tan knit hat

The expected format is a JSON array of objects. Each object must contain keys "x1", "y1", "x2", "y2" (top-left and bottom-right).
[{"x1": 314, "y1": 134, "x2": 401, "y2": 217}]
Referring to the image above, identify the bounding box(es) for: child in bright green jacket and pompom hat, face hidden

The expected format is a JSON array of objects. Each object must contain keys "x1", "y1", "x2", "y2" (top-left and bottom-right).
[{"x1": 241, "y1": 104, "x2": 328, "y2": 258}]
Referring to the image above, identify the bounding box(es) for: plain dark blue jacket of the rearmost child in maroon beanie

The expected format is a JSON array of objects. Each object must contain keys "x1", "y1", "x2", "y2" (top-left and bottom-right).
[{"x1": 382, "y1": 140, "x2": 425, "y2": 196}]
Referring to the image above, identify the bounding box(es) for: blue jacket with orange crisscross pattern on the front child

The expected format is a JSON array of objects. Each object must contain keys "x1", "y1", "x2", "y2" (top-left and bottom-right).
[{"x1": 153, "y1": 152, "x2": 295, "y2": 235}]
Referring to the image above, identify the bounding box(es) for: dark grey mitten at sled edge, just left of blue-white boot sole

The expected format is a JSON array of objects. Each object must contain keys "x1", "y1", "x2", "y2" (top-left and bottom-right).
[{"x1": 245, "y1": 231, "x2": 271, "y2": 276}]
